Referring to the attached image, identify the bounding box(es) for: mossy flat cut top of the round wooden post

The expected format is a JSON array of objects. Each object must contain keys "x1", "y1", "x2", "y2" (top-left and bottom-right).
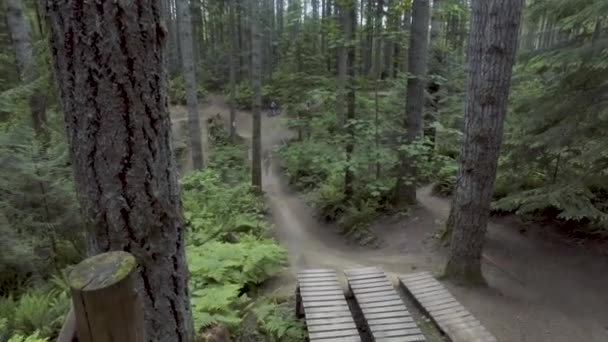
[{"x1": 69, "y1": 251, "x2": 137, "y2": 291}]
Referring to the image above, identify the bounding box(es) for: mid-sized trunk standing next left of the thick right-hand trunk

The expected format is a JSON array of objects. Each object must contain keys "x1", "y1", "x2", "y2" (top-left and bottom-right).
[{"x1": 395, "y1": 0, "x2": 430, "y2": 206}]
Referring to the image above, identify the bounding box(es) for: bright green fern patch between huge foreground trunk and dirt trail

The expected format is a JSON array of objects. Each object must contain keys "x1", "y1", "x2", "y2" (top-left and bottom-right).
[{"x1": 182, "y1": 143, "x2": 287, "y2": 336}]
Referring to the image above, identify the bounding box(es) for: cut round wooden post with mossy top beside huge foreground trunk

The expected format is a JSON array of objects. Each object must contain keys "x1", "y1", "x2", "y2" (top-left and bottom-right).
[{"x1": 69, "y1": 251, "x2": 144, "y2": 342}]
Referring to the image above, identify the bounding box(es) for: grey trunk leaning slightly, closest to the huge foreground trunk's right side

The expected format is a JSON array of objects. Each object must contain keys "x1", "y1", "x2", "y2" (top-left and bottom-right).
[{"x1": 176, "y1": 0, "x2": 206, "y2": 170}]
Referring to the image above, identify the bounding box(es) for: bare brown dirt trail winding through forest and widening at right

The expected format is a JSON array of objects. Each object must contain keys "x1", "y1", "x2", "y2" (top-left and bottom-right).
[{"x1": 172, "y1": 95, "x2": 608, "y2": 342}]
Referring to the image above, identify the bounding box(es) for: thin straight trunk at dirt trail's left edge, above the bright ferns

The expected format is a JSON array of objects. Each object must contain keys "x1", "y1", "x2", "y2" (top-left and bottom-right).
[{"x1": 249, "y1": 1, "x2": 262, "y2": 192}]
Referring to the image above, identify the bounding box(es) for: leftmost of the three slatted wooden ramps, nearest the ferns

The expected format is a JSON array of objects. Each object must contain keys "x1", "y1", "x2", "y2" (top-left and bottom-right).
[{"x1": 296, "y1": 270, "x2": 361, "y2": 342}]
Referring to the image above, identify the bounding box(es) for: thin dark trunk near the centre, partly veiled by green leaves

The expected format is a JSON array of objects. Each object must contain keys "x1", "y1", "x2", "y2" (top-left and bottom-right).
[{"x1": 336, "y1": 0, "x2": 357, "y2": 201}]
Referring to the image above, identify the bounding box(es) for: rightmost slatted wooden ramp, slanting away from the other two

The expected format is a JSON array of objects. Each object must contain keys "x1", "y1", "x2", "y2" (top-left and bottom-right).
[{"x1": 399, "y1": 272, "x2": 497, "y2": 342}]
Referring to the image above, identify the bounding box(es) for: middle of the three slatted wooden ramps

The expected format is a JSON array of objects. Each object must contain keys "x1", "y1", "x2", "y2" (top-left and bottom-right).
[{"x1": 345, "y1": 267, "x2": 426, "y2": 342}]
